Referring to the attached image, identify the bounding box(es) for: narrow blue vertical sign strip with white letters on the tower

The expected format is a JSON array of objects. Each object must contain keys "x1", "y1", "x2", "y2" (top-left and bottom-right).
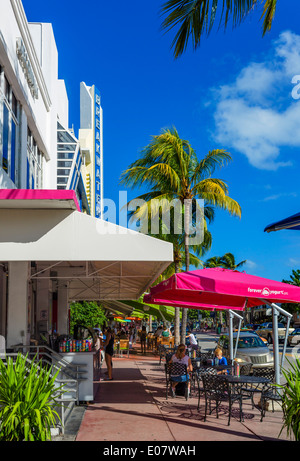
[{"x1": 95, "y1": 87, "x2": 102, "y2": 218}]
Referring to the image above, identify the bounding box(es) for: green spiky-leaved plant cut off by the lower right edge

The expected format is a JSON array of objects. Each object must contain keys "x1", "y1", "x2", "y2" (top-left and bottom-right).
[{"x1": 279, "y1": 358, "x2": 300, "y2": 441}]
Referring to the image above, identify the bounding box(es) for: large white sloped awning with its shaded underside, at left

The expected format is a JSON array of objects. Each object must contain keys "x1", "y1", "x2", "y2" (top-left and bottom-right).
[{"x1": 0, "y1": 190, "x2": 173, "y2": 301}]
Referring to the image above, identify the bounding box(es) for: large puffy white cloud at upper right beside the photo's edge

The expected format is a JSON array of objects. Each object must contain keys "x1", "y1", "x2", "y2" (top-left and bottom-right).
[{"x1": 214, "y1": 32, "x2": 300, "y2": 170}]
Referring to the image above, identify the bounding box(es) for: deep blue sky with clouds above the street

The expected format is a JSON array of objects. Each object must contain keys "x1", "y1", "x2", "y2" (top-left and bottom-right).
[{"x1": 23, "y1": 0, "x2": 300, "y2": 281}]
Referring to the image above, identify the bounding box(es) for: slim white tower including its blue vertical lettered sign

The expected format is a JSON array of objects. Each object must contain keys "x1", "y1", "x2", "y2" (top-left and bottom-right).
[{"x1": 79, "y1": 82, "x2": 103, "y2": 218}]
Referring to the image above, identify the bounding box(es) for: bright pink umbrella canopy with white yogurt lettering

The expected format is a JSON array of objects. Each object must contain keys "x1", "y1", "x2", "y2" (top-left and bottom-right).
[{"x1": 144, "y1": 268, "x2": 300, "y2": 310}]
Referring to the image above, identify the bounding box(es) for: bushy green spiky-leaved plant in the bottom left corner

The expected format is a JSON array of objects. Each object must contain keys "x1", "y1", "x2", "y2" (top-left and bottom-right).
[{"x1": 0, "y1": 354, "x2": 63, "y2": 441}]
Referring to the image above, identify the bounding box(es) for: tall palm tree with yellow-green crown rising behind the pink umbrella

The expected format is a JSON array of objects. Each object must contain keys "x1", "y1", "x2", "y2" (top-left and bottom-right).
[{"x1": 121, "y1": 128, "x2": 241, "y2": 344}]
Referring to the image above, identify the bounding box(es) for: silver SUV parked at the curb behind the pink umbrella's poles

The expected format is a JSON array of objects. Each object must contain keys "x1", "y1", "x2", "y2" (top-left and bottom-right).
[{"x1": 218, "y1": 331, "x2": 274, "y2": 368}]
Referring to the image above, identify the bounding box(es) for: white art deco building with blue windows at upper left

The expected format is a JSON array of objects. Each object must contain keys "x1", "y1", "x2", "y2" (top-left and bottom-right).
[{"x1": 0, "y1": 0, "x2": 90, "y2": 213}]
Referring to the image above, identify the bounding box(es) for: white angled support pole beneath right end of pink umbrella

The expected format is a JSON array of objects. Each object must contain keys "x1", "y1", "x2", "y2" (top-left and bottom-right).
[{"x1": 261, "y1": 299, "x2": 293, "y2": 384}]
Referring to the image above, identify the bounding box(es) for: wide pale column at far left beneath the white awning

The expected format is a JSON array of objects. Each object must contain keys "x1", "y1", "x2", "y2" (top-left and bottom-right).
[{"x1": 7, "y1": 261, "x2": 30, "y2": 348}]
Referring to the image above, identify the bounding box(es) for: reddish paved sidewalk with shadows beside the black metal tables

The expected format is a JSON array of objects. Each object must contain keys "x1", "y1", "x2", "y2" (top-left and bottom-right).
[{"x1": 65, "y1": 346, "x2": 289, "y2": 443}]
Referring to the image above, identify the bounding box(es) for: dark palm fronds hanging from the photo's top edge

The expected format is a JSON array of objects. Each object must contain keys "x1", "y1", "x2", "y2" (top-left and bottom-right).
[{"x1": 161, "y1": 0, "x2": 277, "y2": 58}]
